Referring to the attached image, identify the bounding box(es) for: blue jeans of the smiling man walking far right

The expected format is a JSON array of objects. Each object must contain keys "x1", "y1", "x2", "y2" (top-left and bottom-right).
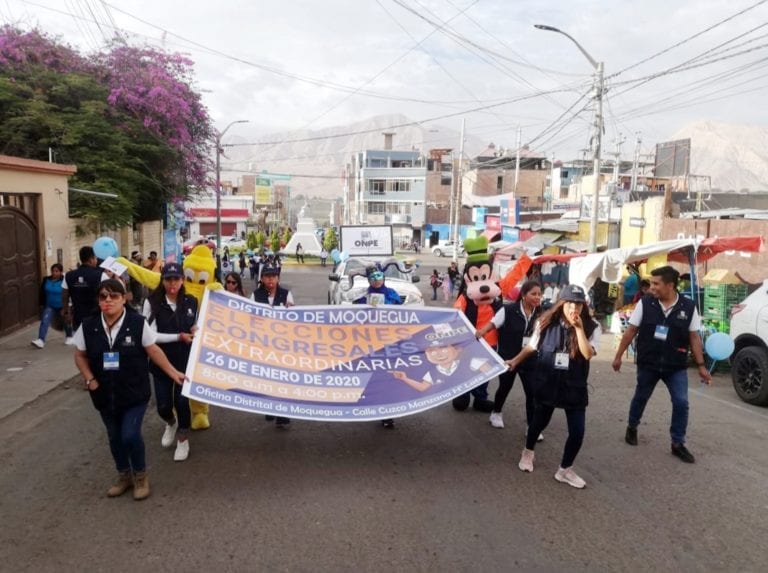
[{"x1": 629, "y1": 368, "x2": 688, "y2": 444}]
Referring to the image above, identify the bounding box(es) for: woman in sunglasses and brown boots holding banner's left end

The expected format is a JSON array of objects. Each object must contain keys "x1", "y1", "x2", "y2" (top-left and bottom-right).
[{"x1": 74, "y1": 279, "x2": 184, "y2": 501}]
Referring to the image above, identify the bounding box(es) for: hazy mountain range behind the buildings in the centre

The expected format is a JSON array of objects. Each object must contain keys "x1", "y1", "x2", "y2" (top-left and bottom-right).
[{"x1": 222, "y1": 114, "x2": 488, "y2": 199}]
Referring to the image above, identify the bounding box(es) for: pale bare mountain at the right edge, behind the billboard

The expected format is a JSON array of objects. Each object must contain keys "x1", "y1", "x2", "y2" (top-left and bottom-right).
[{"x1": 673, "y1": 121, "x2": 768, "y2": 191}]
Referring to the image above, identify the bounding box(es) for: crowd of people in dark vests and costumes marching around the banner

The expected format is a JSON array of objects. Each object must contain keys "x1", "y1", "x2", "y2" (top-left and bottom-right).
[{"x1": 32, "y1": 241, "x2": 712, "y2": 500}]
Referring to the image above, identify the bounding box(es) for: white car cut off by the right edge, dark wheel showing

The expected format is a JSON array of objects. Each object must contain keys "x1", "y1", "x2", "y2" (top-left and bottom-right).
[{"x1": 731, "y1": 279, "x2": 768, "y2": 406}]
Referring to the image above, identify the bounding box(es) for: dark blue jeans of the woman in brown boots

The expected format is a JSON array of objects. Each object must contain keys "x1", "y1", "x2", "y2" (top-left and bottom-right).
[{"x1": 100, "y1": 404, "x2": 147, "y2": 472}]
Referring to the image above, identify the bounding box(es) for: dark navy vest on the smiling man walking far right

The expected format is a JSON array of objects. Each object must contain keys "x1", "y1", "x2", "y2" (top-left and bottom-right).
[{"x1": 637, "y1": 295, "x2": 696, "y2": 372}]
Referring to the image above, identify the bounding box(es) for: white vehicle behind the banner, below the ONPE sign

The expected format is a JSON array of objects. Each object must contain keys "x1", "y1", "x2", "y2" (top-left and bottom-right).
[{"x1": 328, "y1": 257, "x2": 424, "y2": 305}]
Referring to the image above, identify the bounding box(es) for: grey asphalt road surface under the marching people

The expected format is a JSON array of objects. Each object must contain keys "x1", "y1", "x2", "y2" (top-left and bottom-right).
[{"x1": 0, "y1": 256, "x2": 768, "y2": 572}]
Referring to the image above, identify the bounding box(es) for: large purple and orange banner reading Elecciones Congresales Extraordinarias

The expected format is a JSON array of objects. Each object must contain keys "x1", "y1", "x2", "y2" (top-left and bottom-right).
[{"x1": 183, "y1": 291, "x2": 506, "y2": 421}]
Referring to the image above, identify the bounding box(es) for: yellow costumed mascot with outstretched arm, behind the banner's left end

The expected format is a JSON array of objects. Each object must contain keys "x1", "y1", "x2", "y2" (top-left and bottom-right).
[{"x1": 117, "y1": 245, "x2": 224, "y2": 430}]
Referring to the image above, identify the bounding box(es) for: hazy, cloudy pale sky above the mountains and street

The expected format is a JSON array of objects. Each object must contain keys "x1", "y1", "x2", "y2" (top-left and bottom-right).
[{"x1": 0, "y1": 0, "x2": 768, "y2": 163}]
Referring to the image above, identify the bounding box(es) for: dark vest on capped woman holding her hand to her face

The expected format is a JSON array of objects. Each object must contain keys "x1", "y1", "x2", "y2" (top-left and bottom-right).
[{"x1": 535, "y1": 322, "x2": 589, "y2": 410}]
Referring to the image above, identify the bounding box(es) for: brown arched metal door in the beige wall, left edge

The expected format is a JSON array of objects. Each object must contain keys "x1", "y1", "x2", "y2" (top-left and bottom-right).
[{"x1": 0, "y1": 207, "x2": 40, "y2": 336}]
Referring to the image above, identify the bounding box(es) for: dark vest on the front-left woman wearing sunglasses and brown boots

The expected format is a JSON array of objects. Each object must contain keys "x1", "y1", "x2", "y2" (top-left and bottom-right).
[{"x1": 82, "y1": 310, "x2": 150, "y2": 411}]
